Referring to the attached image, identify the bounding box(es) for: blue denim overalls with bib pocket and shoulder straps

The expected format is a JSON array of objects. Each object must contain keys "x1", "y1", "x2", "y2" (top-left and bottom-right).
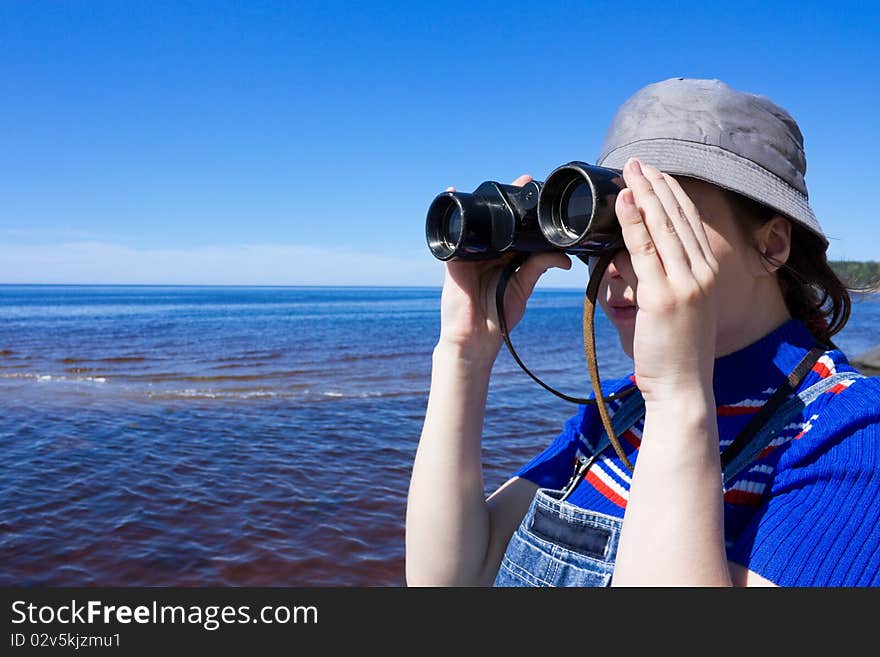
[{"x1": 494, "y1": 372, "x2": 862, "y2": 586}]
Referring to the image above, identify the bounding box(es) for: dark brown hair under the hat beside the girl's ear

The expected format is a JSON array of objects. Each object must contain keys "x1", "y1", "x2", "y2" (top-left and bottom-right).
[{"x1": 725, "y1": 190, "x2": 855, "y2": 348}]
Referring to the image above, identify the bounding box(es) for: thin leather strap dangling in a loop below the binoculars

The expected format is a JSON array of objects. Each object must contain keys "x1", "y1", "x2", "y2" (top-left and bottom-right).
[{"x1": 495, "y1": 252, "x2": 637, "y2": 471}]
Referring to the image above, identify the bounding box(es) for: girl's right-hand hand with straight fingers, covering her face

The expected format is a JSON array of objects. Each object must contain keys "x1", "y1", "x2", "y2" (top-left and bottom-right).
[{"x1": 615, "y1": 159, "x2": 718, "y2": 404}]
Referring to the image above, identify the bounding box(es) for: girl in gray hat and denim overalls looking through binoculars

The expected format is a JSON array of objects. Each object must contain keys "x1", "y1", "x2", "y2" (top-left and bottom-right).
[{"x1": 406, "y1": 78, "x2": 880, "y2": 586}]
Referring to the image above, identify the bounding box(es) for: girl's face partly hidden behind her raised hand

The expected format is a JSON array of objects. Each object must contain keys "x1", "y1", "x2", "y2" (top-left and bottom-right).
[{"x1": 598, "y1": 177, "x2": 775, "y2": 358}]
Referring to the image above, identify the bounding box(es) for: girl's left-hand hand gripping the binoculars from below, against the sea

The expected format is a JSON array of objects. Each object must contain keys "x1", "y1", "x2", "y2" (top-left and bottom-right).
[{"x1": 440, "y1": 175, "x2": 571, "y2": 364}]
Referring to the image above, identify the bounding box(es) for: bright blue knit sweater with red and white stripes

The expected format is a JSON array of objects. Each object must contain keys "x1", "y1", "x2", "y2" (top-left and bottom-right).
[{"x1": 516, "y1": 320, "x2": 880, "y2": 586}]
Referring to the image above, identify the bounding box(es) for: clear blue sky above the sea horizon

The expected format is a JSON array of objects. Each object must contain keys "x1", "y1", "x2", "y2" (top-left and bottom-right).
[{"x1": 0, "y1": 0, "x2": 880, "y2": 285}]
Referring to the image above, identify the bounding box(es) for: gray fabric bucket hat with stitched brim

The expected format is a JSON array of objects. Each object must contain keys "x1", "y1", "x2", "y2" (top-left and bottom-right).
[{"x1": 596, "y1": 78, "x2": 828, "y2": 248}]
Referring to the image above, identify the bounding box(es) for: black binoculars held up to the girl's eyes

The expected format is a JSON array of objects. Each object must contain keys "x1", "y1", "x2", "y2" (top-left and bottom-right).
[{"x1": 425, "y1": 162, "x2": 626, "y2": 260}]
